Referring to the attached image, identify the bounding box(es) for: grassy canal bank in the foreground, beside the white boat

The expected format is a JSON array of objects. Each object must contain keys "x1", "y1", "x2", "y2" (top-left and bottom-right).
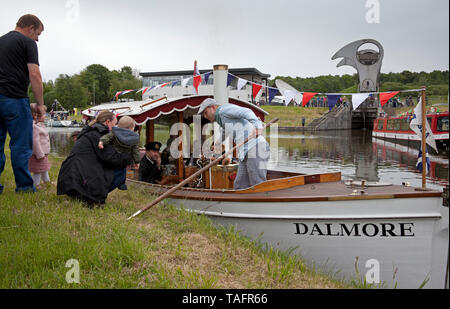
[{"x1": 0, "y1": 146, "x2": 348, "y2": 288}]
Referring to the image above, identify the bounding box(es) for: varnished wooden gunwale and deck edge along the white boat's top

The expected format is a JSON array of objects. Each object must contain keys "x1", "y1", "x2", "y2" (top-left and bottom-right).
[{"x1": 125, "y1": 173, "x2": 442, "y2": 202}]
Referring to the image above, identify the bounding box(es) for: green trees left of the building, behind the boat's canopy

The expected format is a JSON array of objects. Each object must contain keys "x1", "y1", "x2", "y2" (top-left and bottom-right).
[{"x1": 28, "y1": 64, "x2": 142, "y2": 110}]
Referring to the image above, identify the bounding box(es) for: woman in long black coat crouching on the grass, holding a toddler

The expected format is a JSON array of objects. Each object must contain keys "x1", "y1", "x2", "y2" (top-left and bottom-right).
[{"x1": 57, "y1": 111, "x2": 132, "y2": 204}]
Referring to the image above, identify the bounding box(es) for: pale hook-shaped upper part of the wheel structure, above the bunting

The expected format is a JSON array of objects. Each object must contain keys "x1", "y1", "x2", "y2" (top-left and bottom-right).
[{"x1": 331, "y1": 39, "x2": 384, "y2": 92}]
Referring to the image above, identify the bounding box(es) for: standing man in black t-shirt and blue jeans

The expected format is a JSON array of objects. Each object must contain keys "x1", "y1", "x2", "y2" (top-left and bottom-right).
[{"x1": 0, "y1": 14, "x2": 45, "y2": 193}]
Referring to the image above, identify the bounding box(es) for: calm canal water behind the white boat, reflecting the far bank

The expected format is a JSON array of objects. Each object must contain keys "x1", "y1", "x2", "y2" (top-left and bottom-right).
[{"x1": 49, "y1": 128, "x2": 449, "y2": 190}]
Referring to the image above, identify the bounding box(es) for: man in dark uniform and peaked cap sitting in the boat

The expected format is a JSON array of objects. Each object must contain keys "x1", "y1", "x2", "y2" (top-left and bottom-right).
[{"x1": 139, "y1": 142, "x2": 162, "y2": 183}]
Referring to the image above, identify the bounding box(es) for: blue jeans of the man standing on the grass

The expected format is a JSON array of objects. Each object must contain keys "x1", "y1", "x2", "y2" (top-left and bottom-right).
[{"x1": 0, "y1": 95, "x2": 36, "y2": 193}]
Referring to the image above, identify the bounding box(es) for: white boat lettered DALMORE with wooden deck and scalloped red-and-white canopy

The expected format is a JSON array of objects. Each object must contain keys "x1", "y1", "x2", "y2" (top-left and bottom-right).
[{"x1": 83, "y1": 63, "x2": 449, "y2": 288}]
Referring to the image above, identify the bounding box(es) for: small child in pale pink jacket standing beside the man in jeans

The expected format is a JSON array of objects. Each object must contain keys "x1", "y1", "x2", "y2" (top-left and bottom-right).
[{"x1": 28, "y1": 103, "x2": 51, "y2": 189}]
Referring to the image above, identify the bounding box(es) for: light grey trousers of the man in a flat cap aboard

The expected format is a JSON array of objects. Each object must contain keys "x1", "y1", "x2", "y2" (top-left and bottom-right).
[{"x1": 234, "y1": 143, "x2": 270, "y2": 190}]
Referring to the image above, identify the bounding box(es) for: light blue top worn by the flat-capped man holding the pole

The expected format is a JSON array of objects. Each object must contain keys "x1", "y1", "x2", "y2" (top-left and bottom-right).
[{"x1": 215, "y1": 104, "x2": 267, "y2": 161}]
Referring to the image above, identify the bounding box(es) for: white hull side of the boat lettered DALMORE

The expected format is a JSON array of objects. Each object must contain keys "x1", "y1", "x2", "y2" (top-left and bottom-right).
[{"x1": 169, "y1": 197, "x2": 449, "y2": 288}]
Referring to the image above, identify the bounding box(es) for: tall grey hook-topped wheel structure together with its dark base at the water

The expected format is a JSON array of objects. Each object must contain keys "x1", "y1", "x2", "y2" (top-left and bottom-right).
[{"x1": 331, "y1": 39, "x2": 384, "y2": 129}]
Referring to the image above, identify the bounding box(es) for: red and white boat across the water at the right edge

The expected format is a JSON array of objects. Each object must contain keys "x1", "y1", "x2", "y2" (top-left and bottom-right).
[{"x1": 372, "y1": 112, "x2": 450, "y2": 153}]
